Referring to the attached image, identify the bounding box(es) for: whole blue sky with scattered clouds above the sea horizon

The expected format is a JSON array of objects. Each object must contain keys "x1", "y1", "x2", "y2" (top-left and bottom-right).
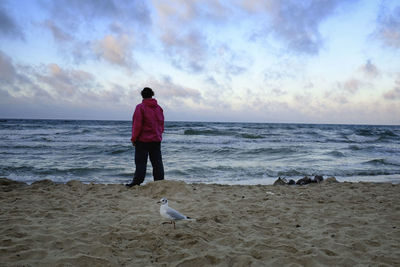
[{"x1": 0, "y1": 0, "x2": 400, "y2": 125}]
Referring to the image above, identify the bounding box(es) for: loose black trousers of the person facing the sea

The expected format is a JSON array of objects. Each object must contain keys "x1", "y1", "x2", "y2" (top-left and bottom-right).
[{"x1": 133, "y1": 141, "x2": 164, "y2": 185}]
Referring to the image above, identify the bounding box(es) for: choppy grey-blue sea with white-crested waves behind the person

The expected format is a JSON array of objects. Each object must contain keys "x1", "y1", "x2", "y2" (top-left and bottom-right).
[{"x1": 0, "y1": 119, "x2": 400, "y2": 185}]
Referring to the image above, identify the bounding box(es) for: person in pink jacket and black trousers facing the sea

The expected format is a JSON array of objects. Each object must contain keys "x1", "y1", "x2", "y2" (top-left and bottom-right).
[{"x1": 126, "y1": 87, "x2": 164, "y2": 187}]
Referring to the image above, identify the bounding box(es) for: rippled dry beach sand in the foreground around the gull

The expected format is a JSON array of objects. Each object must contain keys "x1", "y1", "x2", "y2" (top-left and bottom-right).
[{"x1": 0, "y1": 179, "x2": 400, "y2": 266}]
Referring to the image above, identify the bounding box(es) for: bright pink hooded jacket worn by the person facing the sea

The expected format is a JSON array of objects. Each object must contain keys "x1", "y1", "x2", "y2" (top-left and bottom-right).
[{"x1": 131, "y1": 98, "x2": 164, "y2": 142}]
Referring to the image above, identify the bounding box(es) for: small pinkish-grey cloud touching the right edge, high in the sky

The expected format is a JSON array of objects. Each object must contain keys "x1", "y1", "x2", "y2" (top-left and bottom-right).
[{"x1": 375, "y1": 5, "x2": 400, "y2": 49}]
